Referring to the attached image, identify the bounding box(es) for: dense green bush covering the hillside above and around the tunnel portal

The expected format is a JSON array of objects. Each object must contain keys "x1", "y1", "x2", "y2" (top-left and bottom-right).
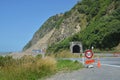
[{"x1": 48, "y1": 0, "x2": 120, "y2": 52}]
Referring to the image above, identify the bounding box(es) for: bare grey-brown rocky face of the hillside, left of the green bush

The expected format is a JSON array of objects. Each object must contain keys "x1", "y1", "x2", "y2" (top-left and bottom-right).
[{"x1": 23, "y1": 0, "x2": 87, "y2": 51}]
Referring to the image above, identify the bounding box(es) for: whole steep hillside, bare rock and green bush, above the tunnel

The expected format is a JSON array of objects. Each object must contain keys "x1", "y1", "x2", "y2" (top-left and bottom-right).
[{"x1": 23, "y1": 0, "x2": 120, "y2": 52}]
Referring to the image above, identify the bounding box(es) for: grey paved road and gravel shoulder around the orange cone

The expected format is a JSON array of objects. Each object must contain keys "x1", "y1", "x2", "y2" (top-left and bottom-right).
[{"x1": 46, "y1": 57, "x2": 120, "y2": 80}]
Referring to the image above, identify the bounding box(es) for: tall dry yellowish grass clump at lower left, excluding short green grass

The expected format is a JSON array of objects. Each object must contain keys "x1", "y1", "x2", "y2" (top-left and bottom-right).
[{"x1": 0, "y1": 56, "x2": 56, "y2": 80}]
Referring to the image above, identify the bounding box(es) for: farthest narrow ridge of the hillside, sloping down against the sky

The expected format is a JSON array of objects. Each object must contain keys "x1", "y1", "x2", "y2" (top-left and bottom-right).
[{"x1": 23, "y1": 14, "x2": 62, "y2": 51}]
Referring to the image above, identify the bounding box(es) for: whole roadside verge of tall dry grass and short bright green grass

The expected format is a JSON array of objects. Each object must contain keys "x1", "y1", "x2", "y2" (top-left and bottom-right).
[{"x1": 0, "y1": 55, "x2": 83, "y2": 80}]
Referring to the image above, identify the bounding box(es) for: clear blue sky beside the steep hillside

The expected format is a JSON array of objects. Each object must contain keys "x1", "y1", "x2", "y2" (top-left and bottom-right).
[{"x1": 0, "y1": 0, "x2": 79, "y2": 52}]
